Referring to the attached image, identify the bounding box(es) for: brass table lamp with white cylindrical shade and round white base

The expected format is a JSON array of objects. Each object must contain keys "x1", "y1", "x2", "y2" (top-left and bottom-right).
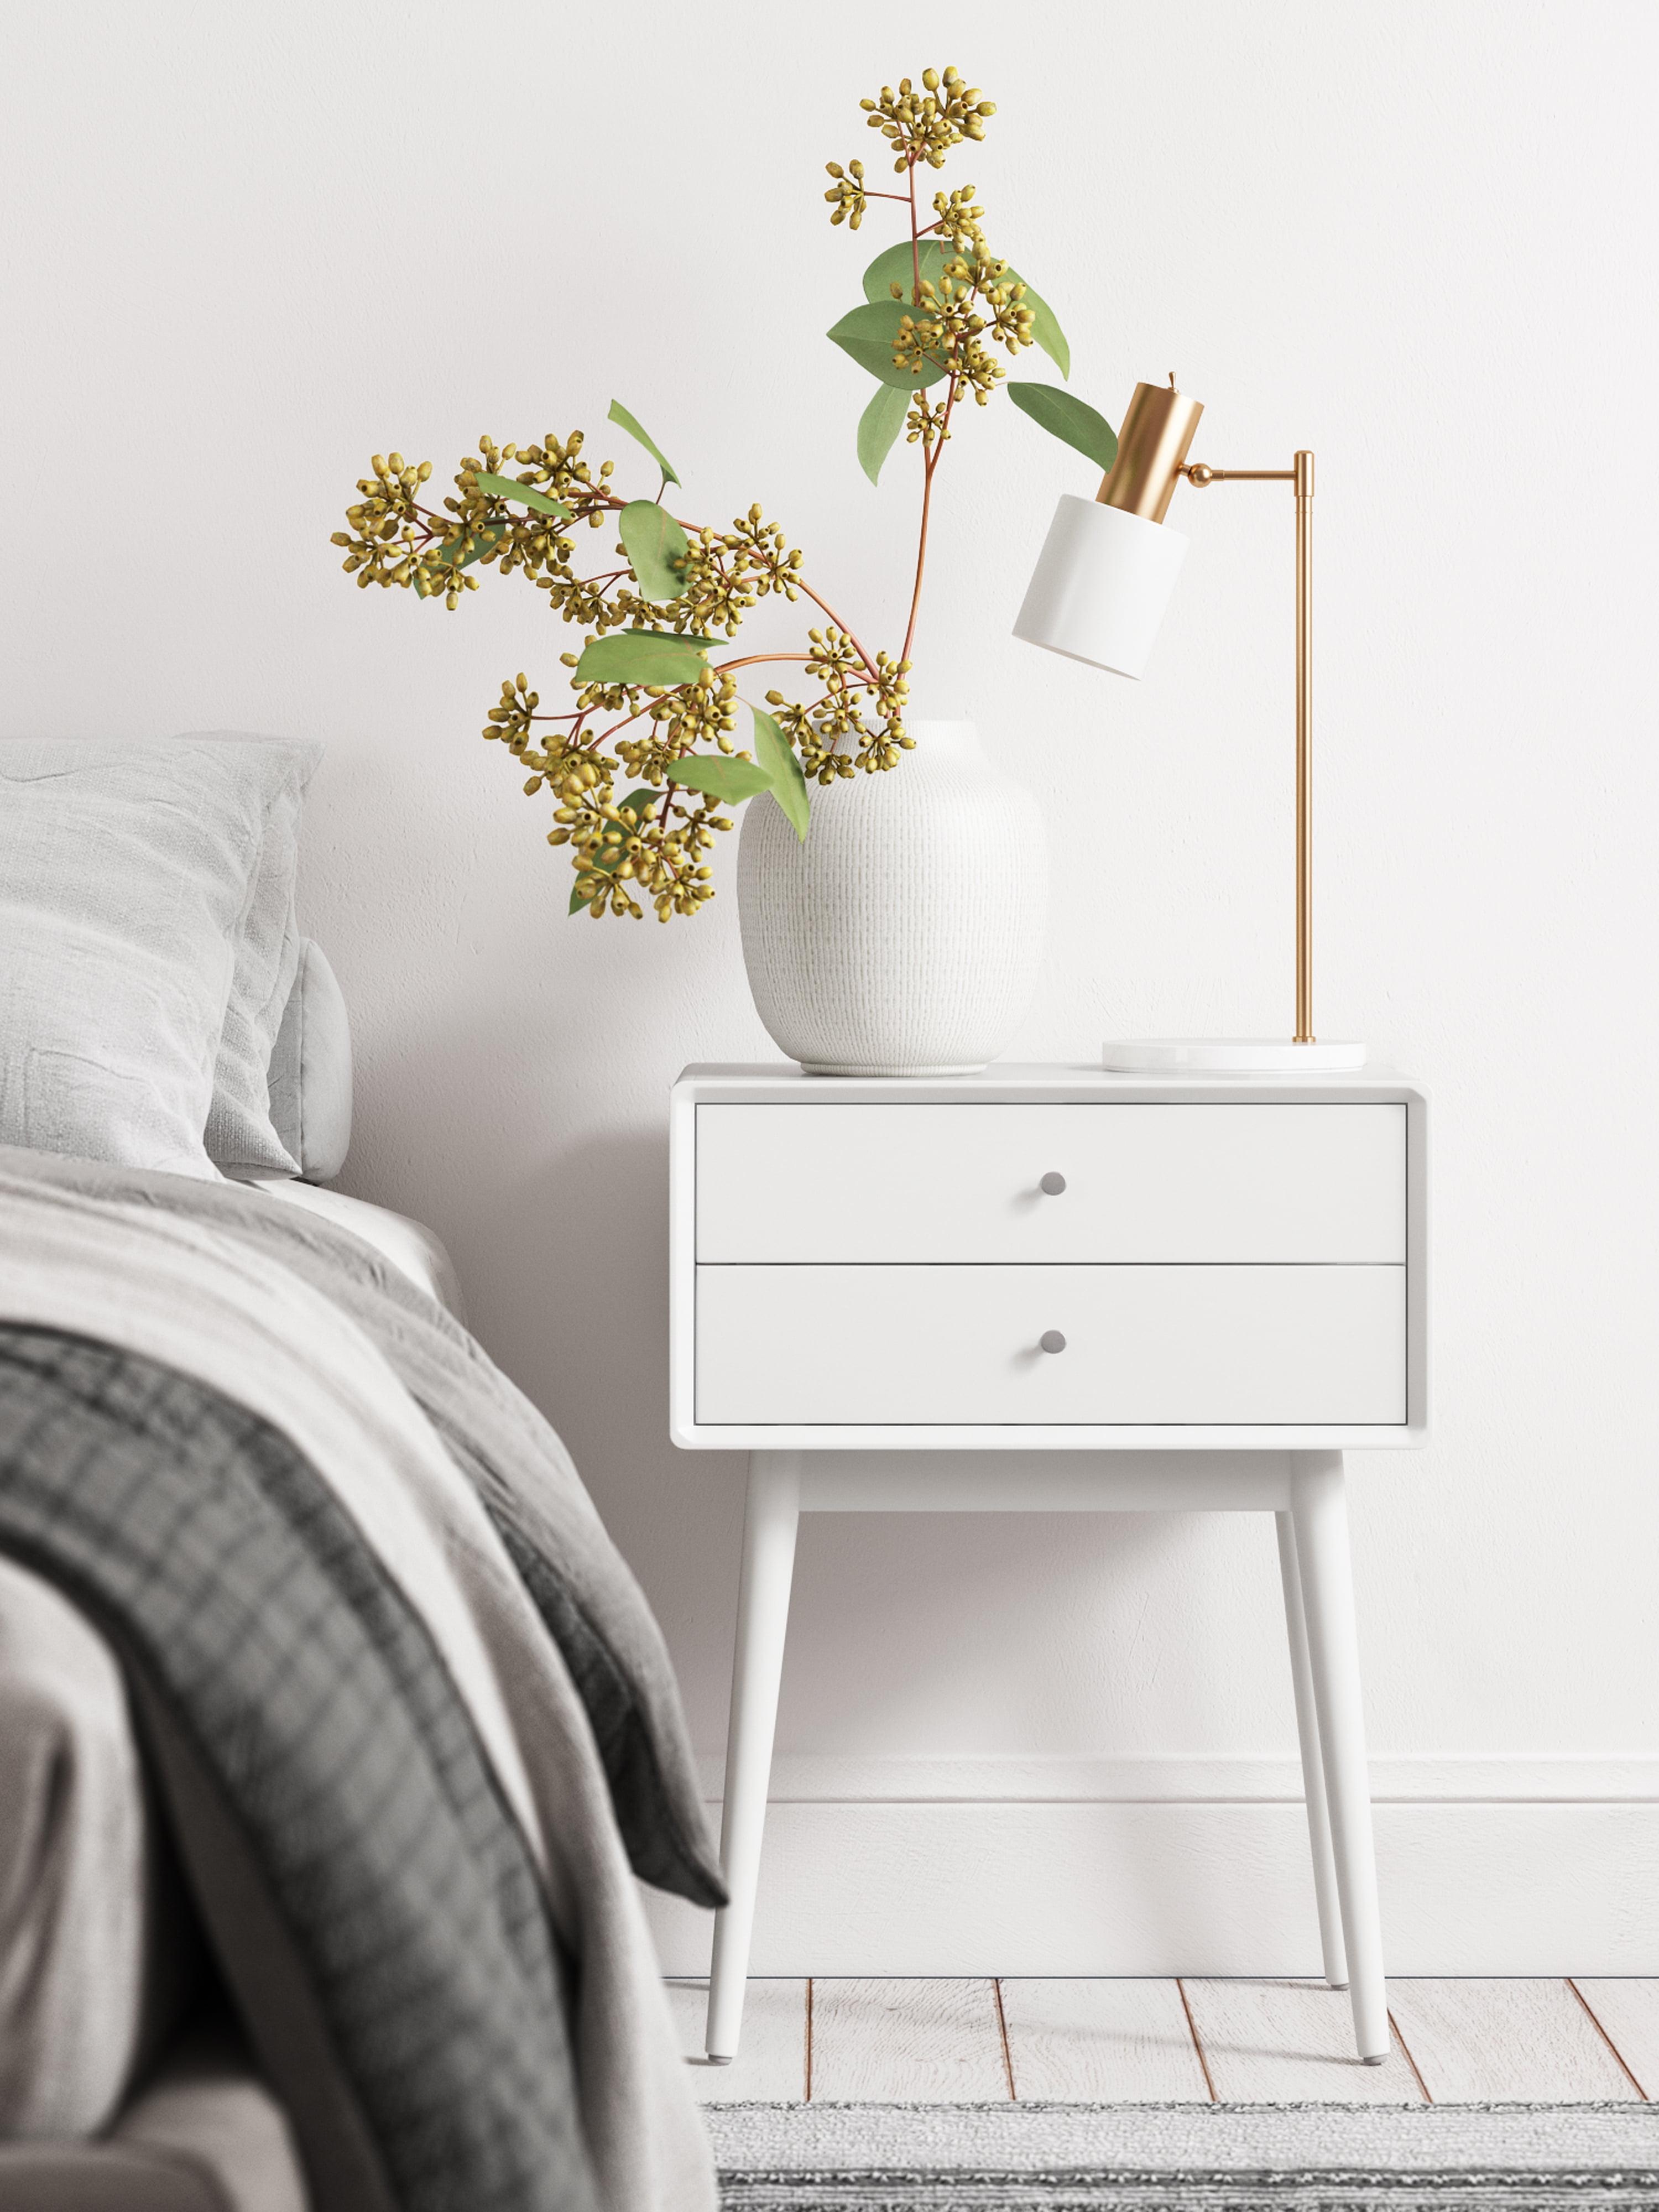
[{"x1": 1013, "y1": 376, "x2": 1365, "y2": 1075}]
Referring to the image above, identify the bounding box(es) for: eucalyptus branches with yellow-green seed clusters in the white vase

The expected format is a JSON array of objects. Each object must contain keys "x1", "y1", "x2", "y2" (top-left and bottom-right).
[{"x1": 334, "y1": 69, "x2": 1066, "y2": 920}]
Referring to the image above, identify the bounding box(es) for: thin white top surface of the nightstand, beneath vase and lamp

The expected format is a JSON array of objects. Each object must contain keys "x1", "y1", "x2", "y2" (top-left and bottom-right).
[{"x1": 675, "y1": 1060, "x2": 1422, "y2": 1104}]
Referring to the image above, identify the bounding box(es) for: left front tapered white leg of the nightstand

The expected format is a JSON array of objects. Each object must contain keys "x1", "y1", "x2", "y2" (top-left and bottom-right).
[{"x1": 706, "y1": 1451, "x2": 801, "y2": 2066}]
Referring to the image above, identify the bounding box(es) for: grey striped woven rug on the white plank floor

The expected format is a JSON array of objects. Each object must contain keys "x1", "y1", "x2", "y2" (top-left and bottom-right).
[{"x1": 706, "y1": 2101, "x2": 1659, "y2": 2212}]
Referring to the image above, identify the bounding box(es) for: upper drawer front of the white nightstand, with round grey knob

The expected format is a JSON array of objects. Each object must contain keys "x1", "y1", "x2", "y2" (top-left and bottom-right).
[{"x1": 697, "y1": 1102, "x2": 1405, "y2": 1265}]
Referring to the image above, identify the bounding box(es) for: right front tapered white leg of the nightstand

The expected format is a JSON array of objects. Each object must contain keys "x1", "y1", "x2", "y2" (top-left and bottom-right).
[{"x1": 1290, "y1": 1451, "x2": 1389, "y2": 2066}]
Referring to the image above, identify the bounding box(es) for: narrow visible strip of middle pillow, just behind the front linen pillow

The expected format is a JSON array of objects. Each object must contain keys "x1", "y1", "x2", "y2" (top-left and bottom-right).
[{"x1": 188, "y1": 730, "x2": 323, "y2": 1181}]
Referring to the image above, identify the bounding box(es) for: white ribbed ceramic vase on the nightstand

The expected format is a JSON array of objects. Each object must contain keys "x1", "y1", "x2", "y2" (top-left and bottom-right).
[{"x1": 737, "y1": 721, "x2": 1048, "y2": 1075}]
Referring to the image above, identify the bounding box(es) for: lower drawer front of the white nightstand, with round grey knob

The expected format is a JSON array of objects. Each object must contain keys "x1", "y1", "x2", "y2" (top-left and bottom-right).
[{"x1": 697, "y1": 1265, "x2": 1407, "y2": 1427}]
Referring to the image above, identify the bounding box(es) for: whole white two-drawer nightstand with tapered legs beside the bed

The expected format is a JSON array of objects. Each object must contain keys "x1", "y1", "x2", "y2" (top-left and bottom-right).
[{"x1": 670, "y1": 1066, "x2": 1429, "y2": 2062}]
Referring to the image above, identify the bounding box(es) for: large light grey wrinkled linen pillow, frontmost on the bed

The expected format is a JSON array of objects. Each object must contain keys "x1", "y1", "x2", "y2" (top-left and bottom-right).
[{"x1": 0, "y1": 739, "x2": 312, "y2": 1179}]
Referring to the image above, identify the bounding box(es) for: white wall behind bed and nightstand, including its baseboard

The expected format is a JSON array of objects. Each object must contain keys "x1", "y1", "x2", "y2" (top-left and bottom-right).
[{"x1": 0, "y1": 0, "x2": 1659, "y2": 1973}]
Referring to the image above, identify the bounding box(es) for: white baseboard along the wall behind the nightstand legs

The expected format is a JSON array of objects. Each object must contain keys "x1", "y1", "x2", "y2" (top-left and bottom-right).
[{"x1": 648, "y1": 1756, "x2": 1659, "y2": 1975}]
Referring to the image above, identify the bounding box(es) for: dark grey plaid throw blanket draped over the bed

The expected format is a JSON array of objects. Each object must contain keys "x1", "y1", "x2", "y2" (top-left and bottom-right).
[{"x1": 0, "y1": 1327, "x2": 595, "y2": 2212}]
